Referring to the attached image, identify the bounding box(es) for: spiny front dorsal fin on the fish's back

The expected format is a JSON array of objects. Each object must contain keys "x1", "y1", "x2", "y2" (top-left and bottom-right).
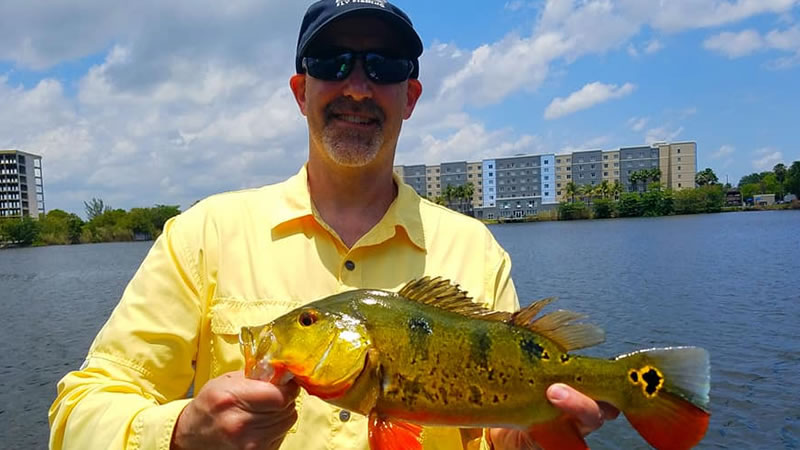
[{"x1": 398, "y1": 277, "x2": 511, "y2": 321}]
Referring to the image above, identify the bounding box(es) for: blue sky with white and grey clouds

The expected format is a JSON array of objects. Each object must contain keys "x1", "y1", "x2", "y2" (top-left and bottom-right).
[{"x1": 0, "y1": 0, "x2": 800, "y2": 214}]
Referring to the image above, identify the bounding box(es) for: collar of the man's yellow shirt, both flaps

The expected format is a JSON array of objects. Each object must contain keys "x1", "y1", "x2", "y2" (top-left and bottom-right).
[{"x1": 271, "y1": 164, "x2": 425, "y2": 251}]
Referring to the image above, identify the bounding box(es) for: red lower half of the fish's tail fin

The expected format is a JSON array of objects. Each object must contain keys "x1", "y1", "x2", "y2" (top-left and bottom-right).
[{"x1": 624, "y1": 392, "x2": 711, "y2": 450}]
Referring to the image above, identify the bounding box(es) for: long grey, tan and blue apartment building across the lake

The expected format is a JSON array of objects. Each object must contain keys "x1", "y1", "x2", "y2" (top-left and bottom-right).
[{"x1": 394, "y1": 142, "x2": 697, "y2": 219}]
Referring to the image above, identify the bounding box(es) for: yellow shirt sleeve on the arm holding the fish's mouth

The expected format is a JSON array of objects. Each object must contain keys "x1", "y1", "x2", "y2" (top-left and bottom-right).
[{"x1": 49, "y1": 216, "x2": 203, "y2": 450}]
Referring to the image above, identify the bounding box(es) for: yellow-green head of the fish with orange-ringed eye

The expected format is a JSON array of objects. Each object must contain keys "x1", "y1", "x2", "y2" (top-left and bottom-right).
[{"x1": 240, "y1": 305, "x2": 370, "y2": 398}]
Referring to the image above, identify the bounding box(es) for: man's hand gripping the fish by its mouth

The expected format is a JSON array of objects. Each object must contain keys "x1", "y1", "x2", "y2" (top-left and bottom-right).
[{"x1": 170, "y1": 371, "x2": 299, "y2": 450}]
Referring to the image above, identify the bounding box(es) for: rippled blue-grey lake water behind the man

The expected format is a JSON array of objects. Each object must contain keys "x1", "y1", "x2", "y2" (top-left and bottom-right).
[{"x1": 0, "y1": 211, "x2": 800, "y2": 449}]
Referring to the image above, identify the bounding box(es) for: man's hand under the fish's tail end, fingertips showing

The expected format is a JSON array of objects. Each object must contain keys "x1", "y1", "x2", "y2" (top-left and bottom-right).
[{"x1": 490, "y1": 384, "x2": 619, "y2": 450}]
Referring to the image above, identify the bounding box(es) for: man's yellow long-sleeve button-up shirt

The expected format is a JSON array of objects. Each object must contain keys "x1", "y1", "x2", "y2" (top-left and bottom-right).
[{"x1": 49, "y1": 168, "x2": 519, "y2": 450}]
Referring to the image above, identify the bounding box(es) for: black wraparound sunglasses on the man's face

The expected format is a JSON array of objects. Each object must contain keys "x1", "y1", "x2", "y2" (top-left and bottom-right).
[{"x1": 303, "y1": 50, "x2": 414, "y2": 84}]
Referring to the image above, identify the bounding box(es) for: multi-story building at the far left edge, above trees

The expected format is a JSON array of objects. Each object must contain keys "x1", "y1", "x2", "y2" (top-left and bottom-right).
[{"x1": 0, "y1": 150, "x2": 45, "y2": 217}]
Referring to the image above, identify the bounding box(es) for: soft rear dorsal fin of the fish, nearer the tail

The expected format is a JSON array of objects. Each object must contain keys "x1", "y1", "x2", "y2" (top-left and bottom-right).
[{"x1": 511, "y1": 297, "x2": 605, "y2": 352}]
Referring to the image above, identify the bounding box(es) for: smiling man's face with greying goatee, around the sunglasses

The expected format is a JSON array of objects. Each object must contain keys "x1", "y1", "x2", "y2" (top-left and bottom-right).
[{"x1": 291, "y1": 18, "x2": 422, "y2": 167}]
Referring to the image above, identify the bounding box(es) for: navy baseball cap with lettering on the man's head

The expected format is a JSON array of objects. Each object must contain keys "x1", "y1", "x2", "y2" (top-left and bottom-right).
[{"x1": 295, "y1": 0, "x2": 422, "y2": 78}]
